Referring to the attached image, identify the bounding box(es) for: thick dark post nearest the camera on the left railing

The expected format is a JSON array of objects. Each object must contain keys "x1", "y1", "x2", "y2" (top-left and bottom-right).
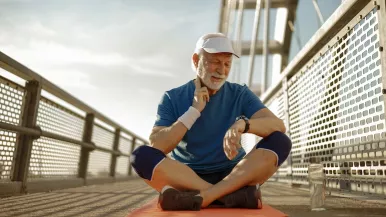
[{"x1": 11, "y1": 80, "x2": 42, "y2": 192}]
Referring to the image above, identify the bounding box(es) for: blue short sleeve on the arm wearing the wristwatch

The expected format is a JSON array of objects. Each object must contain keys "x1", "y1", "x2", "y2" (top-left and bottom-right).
[{"x1": 242, "y1": 87, "x2": 266, "y2": 118}]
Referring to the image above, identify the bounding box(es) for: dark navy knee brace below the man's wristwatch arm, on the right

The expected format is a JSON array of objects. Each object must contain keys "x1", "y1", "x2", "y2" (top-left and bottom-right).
[{"x1": 256, "y1": 131, "x2": 292, "y2": 166}]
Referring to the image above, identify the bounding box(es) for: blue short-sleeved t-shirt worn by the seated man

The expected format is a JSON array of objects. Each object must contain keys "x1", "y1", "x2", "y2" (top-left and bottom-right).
[{"x1": 155, "y1": 80, "x2": 265, "y2": 173}]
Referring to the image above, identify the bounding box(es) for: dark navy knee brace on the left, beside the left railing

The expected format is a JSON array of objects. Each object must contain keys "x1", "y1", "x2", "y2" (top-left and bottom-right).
[{"x1": 130, "y1": 145, "x2": 166, "y2": 181}]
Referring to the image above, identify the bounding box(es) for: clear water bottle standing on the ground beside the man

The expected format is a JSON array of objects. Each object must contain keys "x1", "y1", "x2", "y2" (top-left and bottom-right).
[{"x1": 308, "y1": 157, "x2": 326, "y2": 211}]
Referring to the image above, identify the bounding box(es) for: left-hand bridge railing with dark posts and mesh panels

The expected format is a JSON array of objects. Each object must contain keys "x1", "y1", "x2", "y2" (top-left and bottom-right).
[{"x1": 0, "y1": 52, "x2": 148, "y2": 196}]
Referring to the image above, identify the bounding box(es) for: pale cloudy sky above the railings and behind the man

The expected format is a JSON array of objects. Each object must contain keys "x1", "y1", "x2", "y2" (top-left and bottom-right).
[{"x1": 0, "y1": 0, "x2": 340, "y2": 139}]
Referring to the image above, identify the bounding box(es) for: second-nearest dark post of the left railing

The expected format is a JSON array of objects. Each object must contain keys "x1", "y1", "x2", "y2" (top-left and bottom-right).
[{"x1": 78, "y1": 113, "x2": 95, "y2": 180}]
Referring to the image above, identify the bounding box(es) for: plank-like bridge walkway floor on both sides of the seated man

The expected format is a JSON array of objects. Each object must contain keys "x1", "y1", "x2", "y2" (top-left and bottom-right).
[{"x1": 0, "y1": 179, "x2": 386, "y2": 217}]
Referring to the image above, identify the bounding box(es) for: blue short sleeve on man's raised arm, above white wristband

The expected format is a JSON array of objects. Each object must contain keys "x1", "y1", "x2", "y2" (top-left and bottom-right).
[{"x1": 154, "y1": 92, "x2": 177, "y2": 127}]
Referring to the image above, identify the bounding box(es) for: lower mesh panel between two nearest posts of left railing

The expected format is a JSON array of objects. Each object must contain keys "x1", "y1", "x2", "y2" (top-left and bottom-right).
[{"x1": 28, "y1": 137, "x2": 80, "y2": 179}]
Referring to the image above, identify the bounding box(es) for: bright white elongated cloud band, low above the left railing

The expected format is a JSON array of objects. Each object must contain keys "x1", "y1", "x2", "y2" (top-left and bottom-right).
[{"x1": 2, "y1": 40, "x2": 173, "y2": 77}]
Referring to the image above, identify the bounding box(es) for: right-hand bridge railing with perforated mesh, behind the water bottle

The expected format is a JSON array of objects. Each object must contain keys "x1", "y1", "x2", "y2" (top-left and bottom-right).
[{"x1": 261, "y1": 0, "x2": 386, "y2": 195}]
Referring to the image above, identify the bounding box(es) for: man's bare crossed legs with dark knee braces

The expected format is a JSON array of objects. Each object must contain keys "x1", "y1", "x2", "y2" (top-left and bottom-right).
[{"x1": 131, "y1": 132, "x2": 292, "y2": 207}]
